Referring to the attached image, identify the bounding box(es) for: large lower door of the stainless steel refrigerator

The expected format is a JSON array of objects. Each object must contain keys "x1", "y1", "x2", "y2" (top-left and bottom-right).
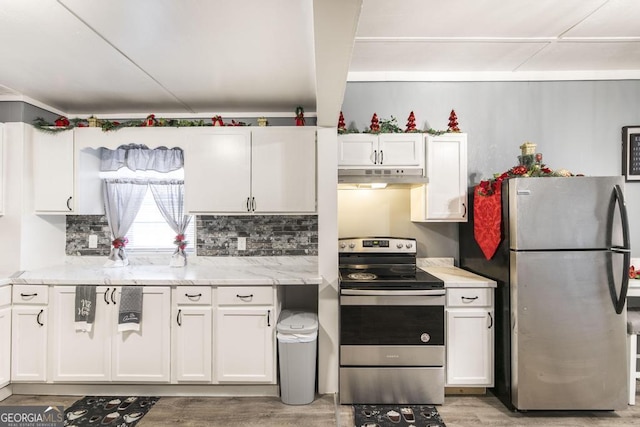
[{"x1": 510, "y1": 251, "x2": 627, "y2": 410}]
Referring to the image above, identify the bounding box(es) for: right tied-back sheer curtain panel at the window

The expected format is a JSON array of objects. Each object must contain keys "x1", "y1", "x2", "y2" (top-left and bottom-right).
[{"x1": 149, "y1": 180, "x2": 191, "y2": 267}]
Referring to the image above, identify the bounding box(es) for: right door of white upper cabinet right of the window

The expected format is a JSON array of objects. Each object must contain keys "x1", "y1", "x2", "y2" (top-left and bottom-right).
[{"x1": 251, "y1": 128, "x2": 316, "y2": 212}]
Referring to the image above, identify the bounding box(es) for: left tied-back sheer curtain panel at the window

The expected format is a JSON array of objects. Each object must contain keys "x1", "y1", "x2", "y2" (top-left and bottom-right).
[{"x1": 103, "y1": 179, "x2": 147, "y2": 267}]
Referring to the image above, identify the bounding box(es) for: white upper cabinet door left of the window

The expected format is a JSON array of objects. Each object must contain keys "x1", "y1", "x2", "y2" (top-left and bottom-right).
[{"x1": 32, "y1": 129, "x2": 75, "y2": 214}]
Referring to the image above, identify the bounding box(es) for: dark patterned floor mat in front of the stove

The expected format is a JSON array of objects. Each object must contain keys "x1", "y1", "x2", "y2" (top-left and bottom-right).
[{"x1": 353, "y1": 405, "x2": 446, "y2": 427}]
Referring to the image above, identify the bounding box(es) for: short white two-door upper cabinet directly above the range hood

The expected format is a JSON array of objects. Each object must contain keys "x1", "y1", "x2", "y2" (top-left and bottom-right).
[{"x1": 338, "y1": 133, "x2": 424, "y2": 169}]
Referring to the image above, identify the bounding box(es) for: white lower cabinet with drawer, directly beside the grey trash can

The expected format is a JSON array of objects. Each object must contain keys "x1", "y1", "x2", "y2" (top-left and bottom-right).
[{"x1": 214, "y1": 286, "x2": 277, "y2": 384}]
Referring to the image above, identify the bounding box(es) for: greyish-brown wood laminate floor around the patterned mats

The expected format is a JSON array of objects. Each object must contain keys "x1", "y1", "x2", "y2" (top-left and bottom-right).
[{"x1": 0, "y1": 393, "x2": 640, "y2": 427}]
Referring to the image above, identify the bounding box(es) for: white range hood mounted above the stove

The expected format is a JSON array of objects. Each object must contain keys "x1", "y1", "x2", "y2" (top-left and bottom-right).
[{"x1": 338, "y1": 168, "x2": 427, "y2": 186}]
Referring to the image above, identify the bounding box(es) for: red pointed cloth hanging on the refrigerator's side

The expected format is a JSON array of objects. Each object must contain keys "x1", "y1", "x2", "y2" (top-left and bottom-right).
[{"x1": 473, "y1": 185, "x2": 502, "y2": 259}]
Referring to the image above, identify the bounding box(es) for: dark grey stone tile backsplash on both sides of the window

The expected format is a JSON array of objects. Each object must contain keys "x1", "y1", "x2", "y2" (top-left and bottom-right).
[{"x1": 66, "y1": 215, "x2": 318, "y2": 256}]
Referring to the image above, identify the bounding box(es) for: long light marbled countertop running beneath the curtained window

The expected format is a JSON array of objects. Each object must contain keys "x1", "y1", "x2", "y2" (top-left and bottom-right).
[{"x1": 11, "y1": 256, "x2": 322, "y2": 286}]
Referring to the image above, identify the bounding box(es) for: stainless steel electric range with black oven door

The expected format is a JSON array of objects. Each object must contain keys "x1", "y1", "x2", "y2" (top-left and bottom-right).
[{"x1": 338, "y1": 237, "x2": 445, "y2": 404}]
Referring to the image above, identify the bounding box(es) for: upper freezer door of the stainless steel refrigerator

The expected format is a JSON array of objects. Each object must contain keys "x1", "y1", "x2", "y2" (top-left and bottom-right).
[{"x1": 508, "y1": 176, "x2": 624, "y2": 250}]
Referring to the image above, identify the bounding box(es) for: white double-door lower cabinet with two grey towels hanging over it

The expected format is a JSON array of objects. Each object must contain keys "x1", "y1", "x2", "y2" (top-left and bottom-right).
[{"x1": 51, "y1": 286, "x2": 171, "y2": 382}]
